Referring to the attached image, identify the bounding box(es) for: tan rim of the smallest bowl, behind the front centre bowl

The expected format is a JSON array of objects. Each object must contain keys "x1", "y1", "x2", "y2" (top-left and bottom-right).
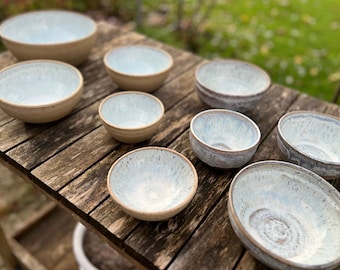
[{"x1": 98, "y1": 91, "x2": 165, "y2": 131}]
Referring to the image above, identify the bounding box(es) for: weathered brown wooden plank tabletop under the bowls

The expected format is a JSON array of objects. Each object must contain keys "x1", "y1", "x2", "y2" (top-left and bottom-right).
[{"x1": 0, "y1": 20, "x2": 340, "y2": 269}]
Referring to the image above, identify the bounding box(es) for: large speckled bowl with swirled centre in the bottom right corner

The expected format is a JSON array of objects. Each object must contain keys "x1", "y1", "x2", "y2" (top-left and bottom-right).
[{"x1": 228, "y1": 161, "x2": 340, "y2": 269}]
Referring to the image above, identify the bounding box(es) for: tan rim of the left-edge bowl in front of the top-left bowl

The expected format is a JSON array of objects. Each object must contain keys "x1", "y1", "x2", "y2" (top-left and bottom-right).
[{"x1": 0, "y1": 59, "x2": 84, "y2": 109}]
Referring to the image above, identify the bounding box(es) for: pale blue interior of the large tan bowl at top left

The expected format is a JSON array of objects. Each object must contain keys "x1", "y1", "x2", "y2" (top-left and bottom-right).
[{"x1": 0, "y1": 11, "x2": 96, "y2": 44}]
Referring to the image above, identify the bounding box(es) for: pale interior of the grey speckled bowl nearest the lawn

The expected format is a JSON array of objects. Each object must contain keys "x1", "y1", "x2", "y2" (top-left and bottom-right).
[{"x1": 196, "y1": 60, "x2": 270, "y2": 96}]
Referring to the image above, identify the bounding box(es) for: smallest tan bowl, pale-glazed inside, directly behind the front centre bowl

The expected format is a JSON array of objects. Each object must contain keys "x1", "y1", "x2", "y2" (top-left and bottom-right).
[{"x1": 98, "y1": 91, "x2": 164, "y2": 143}]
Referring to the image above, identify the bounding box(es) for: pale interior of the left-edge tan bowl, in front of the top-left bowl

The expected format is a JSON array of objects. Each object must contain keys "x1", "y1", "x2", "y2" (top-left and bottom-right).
[{"x1": 0, "y1": 61, "x2": 82, "y2": 106}]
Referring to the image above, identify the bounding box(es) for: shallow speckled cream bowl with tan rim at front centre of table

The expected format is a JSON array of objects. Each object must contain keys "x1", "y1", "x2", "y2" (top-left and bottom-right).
[{"x1": 107, "y1": 146, "x2": 198, "y2": 221}]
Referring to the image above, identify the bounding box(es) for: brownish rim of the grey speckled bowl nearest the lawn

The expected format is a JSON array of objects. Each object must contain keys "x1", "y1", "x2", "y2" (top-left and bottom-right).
[{"x1": 195, "y1": 59, "x2": 272, "y2": 98}]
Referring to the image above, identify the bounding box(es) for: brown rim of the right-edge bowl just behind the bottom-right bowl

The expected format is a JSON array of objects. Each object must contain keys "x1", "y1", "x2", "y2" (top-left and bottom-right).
[{"x1": 277, "y1": 110, "x2": 340, "y2": 166}]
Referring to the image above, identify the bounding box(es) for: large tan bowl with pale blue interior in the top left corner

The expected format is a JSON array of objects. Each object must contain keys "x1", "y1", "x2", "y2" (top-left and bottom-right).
[{"x1": 0, "y1": 10, "x2": 97, "y2": 65}]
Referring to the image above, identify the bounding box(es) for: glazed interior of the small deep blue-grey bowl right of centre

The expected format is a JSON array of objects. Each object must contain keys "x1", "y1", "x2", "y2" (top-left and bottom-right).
[{"x1": 191, "y1": 110, "x2": 260, "y2": 151}]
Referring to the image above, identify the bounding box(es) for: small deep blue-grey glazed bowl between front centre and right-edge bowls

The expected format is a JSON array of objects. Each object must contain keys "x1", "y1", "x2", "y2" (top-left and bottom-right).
[{"x1": 189, "y1": 109, "x2": 261, "y2": 169}]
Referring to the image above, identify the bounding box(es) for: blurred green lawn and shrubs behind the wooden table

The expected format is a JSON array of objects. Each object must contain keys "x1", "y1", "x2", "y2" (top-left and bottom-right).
[{"x1": 0, "y1": 0, "x2": 340, "y2": 103}]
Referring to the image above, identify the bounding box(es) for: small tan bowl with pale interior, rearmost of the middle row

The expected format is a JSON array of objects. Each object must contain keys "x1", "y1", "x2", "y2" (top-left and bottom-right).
[{"x1": 104, "y1": 45, "x2": 173, "y2": 92}]
